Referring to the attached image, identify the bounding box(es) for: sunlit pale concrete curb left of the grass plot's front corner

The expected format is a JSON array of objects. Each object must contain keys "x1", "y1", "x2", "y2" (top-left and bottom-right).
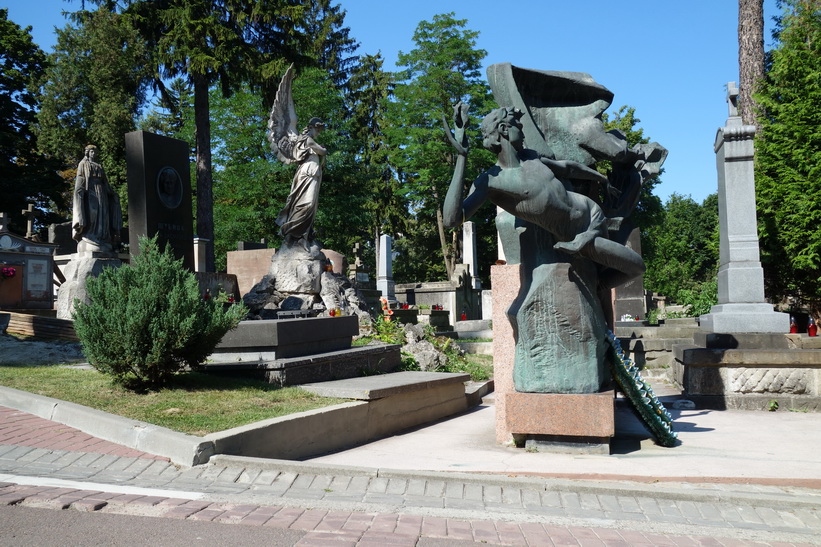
[{"x1": 0, "y1": 386, "x2": 214, "y2": 466}]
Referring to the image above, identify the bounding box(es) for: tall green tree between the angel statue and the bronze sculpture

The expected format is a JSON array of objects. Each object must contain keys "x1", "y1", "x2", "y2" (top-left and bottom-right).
[{"x1": 388, "y1": 13, "x2": 493, "y2": 279}]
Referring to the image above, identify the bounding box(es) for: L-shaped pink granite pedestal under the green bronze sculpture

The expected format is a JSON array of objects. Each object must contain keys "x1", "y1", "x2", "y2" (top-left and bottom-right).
[{"x1": 490, "y1": 265, "x2": 615, "y2": 454}]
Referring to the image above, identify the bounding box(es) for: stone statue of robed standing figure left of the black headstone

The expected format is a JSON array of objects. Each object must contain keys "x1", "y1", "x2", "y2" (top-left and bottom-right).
[{"x1": 71, "y1": 144, "x2": 123, "y2": 256}]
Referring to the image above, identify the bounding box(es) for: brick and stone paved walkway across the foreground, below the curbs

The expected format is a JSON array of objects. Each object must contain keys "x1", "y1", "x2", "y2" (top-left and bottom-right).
[{"x1": 0, "y1": 407, "x2": 821, "y2": 546}]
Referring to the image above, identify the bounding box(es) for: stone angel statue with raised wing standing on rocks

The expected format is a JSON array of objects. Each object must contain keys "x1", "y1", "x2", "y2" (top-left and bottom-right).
[{"x1": 268, "y1": 65, "x2": 327, "y2": 250}]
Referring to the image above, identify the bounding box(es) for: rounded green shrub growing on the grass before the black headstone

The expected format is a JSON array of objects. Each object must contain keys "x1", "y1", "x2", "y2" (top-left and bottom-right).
[{"x1": 74, "y1": 238, "x2": 247, "y2": 390}]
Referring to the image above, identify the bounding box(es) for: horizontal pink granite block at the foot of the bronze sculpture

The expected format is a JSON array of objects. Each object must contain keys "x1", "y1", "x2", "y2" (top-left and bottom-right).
[{"x1": 505, "y1": 391, "x2": 616, "y2": 442}]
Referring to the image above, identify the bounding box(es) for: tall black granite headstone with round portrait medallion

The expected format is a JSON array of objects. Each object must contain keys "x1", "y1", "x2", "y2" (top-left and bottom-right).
[{"x1": 125, "y1": 131, "x2": 194, "y2": 270}]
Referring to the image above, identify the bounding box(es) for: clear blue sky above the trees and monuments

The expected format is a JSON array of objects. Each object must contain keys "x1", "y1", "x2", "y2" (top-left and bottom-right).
[{"x1": 0, "y1": 0, "x2": 778, "y2": 201}]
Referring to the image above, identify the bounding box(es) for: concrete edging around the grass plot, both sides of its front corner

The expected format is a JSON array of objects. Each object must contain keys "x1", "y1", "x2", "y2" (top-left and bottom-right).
[{"x1": 0, "y1": 381, "x2": 493, "y2": 467}]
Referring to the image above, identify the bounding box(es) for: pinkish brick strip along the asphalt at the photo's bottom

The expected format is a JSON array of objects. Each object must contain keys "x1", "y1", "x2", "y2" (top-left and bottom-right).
[{"x1": 0, "y1": 482, "x2": 811, "y2": 547}]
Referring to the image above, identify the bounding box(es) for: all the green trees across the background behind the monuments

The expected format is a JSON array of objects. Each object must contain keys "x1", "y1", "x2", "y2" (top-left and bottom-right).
[{"x1": 9, "y1": 0, "x2": 821, "y2": 316}]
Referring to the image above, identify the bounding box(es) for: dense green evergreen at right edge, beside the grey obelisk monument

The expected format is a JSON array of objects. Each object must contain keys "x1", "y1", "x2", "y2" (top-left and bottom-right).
[{"x1": 756, "y1": 0, "x2": 821, "y2": 312}]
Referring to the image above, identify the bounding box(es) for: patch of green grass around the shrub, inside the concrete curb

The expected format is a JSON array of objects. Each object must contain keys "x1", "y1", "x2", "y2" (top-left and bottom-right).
[{"x1": 0, "y1": 366, "x2": 345, "y2": 435}]
